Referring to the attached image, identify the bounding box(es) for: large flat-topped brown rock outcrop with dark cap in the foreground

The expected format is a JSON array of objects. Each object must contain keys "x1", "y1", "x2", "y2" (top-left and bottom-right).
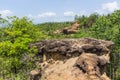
[{"x1": 30, "y1": 38, "x2": 114, "y2": 80}]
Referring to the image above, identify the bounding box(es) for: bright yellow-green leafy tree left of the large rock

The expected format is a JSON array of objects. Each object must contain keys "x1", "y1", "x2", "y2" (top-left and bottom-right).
[{"x1": 0, "y1": 16, "x2": 47, "y2": 79}]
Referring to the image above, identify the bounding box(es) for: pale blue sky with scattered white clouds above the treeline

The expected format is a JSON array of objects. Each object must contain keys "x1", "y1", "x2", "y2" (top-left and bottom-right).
[{"x1": 0, "y1": 0, "x2": 120, "y2": 23}]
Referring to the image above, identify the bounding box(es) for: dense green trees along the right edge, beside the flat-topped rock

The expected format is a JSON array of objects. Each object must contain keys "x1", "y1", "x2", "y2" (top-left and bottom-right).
[{"x1": 89, "y1": 10, "x2": 120, "y2": 80}]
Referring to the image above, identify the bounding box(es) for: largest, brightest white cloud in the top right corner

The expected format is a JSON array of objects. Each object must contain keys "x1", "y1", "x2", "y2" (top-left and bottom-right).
[{"x1": 102, "y1": 1, "x2": 119, "y2": 12}]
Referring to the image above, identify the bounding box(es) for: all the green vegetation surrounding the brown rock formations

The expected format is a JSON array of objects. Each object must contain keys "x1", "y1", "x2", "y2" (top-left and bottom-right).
[{"x1": 0, "y1": 10, "x2": 120, "y2": 80}]
